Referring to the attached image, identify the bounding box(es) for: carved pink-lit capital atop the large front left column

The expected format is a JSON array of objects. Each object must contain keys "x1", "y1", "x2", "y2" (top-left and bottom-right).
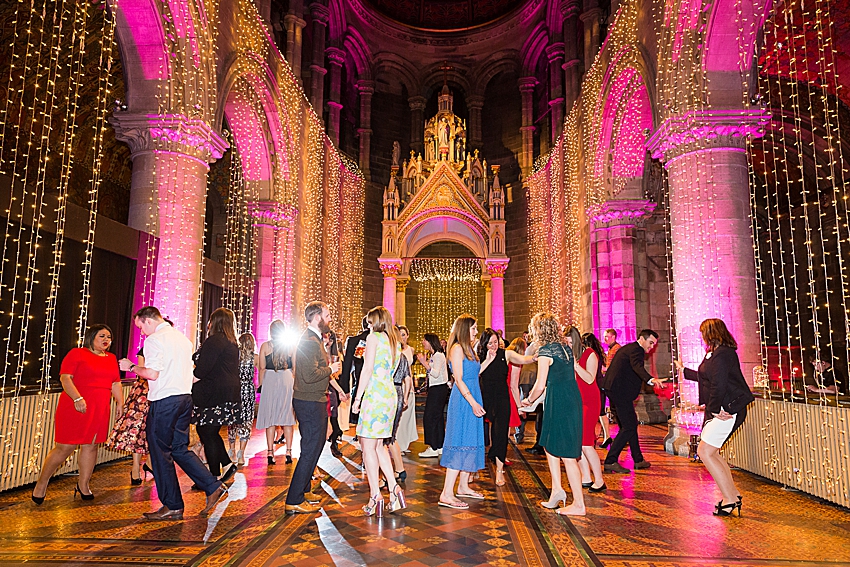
[{"x1": 109, "y1": 112, "x2": 229, "y2": 163}]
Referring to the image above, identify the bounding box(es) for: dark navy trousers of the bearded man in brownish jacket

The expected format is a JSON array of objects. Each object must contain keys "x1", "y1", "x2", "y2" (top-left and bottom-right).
[{"x1": 286, "y1": 399, "x2": 328, "y2": 505}]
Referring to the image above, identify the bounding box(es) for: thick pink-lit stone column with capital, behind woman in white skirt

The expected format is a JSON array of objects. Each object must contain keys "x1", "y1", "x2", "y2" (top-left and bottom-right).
[{"x1": 648, "y1": 110, "x2": 770, "y2": 392}]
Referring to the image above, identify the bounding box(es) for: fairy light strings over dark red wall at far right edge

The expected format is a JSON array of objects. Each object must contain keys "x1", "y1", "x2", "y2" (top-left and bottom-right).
[{"x1": 745, "y1": 0, "x2": 850, "y2": 405}]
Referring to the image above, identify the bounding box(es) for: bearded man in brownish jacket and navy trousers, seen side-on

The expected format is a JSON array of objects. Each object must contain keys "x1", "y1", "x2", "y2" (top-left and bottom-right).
[{"x1": 286, "y1": 301, "x2": 340, "y2": 514}]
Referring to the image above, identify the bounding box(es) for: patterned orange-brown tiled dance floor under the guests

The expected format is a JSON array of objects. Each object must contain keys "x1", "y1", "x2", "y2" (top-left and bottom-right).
[{"x1": 0, "y1": 420, "x2": 850, "y2": 567}]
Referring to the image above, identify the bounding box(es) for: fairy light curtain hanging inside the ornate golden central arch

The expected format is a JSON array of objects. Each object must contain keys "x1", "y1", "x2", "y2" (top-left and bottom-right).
[{"x1": 410, "y1": 258, "x2": 481, "y2": 344}]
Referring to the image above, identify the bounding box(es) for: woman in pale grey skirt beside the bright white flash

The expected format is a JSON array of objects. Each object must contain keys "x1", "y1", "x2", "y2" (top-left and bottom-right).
[{"x1": 257, "y1": 319, "x2": 295, "y2": 465}]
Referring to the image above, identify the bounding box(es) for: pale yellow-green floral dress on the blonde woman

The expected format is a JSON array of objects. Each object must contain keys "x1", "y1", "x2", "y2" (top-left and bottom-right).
[{"x1": 357, "y1": 333, "x2": 402, "y2": 439}]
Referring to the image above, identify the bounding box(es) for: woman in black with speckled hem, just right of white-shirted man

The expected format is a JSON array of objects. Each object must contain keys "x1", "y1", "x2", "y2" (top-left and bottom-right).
[{"x1": 192, "y1": 307, "x2": 242, "y2": 482}]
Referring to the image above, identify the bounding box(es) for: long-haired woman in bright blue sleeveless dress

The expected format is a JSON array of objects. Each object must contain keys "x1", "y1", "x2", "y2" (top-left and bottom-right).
[{"x1": 440, "y1": 314, "x2": 485, "y2": 510}]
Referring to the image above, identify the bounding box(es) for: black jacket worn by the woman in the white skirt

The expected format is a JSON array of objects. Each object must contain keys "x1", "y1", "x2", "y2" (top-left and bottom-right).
[{"x1": 685, "y1": 346, "x2": 755, "y2": 417}]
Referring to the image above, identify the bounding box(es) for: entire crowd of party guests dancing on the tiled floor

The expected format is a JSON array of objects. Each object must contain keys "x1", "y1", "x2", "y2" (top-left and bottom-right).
[{"x1": 32, "y1": 301, "x2": 753, "y2": 520}]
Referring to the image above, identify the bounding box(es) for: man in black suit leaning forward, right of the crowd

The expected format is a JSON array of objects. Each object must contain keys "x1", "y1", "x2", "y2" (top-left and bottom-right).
[{"x1": 602, "y1": 329, "x2": 660, "y2": 473}]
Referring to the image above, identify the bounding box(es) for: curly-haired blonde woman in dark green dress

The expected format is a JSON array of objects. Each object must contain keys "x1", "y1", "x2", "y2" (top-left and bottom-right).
[{"x1": 522, "y1": 313, "x2": 586, "y2": 516}]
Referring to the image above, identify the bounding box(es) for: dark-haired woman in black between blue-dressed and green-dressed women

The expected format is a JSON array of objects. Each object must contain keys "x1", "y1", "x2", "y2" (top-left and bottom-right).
[{"x1": 477, "y1": 329, "x2": 535, "y2": 486}]
